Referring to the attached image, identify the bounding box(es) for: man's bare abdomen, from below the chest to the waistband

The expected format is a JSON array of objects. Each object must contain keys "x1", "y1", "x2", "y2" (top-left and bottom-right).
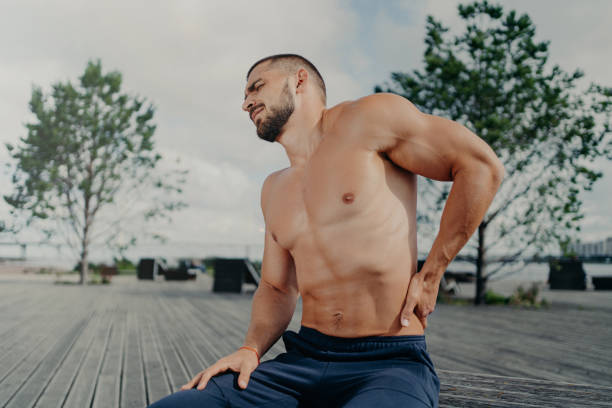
[{"x1": 293, "y1": 212, "x2": 423, "y2": 337}]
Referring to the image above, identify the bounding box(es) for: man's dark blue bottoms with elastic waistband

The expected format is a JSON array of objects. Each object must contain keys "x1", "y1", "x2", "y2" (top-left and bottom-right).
[{"x1": 150, "y1": 326, "x2": 440, "y2": 408}]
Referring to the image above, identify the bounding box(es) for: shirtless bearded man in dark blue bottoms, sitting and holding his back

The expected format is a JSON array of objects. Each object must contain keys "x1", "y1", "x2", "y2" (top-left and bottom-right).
[{"x1": 148, "y1": 54, "x2": 504, "y2": 408}]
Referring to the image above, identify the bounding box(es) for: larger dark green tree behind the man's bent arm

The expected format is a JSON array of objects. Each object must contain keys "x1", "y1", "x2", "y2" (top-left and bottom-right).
[{"x1": 375, "y1": 1, "x2": 612, "y2": 304}]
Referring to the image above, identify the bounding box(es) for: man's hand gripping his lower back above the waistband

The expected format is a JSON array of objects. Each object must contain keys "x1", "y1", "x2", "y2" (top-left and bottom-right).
[{"x1": 400, "y1": 271, "x2": 440, "y2": 329}]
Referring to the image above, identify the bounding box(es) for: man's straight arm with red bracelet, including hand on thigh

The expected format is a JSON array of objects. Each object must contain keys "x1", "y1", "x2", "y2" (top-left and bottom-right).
[{"x1": 181, "y1": 173, "x2": 298, "y2": 390}]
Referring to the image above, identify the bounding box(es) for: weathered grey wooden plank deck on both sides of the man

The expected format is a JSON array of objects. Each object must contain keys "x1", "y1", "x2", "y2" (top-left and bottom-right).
[{"x1": 0, "y1": 275, "x2": 612, "y2": 408}]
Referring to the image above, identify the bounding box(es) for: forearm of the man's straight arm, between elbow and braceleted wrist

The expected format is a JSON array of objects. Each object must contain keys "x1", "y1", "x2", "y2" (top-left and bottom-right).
[{"x1": 244, "y1": 282, "x2": 298, "y2": 357}]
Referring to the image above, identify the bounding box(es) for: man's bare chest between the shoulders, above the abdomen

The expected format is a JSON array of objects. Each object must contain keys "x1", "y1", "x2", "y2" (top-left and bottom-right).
[{"x1": 266, "y1": 145, "x2": 416, "y2": 249}]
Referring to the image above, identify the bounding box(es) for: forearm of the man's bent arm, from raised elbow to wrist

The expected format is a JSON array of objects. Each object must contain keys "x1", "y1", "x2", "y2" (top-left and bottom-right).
[{"x1": 422, "y1": 163, "x2": 503, "y2": 283}]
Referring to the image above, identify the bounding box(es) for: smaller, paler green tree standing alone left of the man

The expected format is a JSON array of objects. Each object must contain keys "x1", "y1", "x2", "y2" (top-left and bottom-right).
[{"x1": 4, "y1": 60, "x2": 185, "y2": 283}]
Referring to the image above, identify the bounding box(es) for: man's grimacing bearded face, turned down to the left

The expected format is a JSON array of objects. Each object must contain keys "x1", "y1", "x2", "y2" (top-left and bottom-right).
[{"x1": 242, "y1": 63, "x2": 295, "y2": 142}]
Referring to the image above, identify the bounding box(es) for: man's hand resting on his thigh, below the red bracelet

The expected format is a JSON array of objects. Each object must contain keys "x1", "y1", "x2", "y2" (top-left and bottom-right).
[{"x1": 181, "y1": 349, "x2": 259, "y2": 391}]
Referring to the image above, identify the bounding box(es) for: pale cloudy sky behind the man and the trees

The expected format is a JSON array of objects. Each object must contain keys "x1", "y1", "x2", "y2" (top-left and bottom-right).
[{"x1": 0, "y1": 0, "x2": 612, "y2": 262}]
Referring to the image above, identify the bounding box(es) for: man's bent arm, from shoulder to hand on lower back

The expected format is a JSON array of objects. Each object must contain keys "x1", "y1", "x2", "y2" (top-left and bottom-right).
[{"x1": 346, "y1": 94, "x2": 504, "y2": 327}]
